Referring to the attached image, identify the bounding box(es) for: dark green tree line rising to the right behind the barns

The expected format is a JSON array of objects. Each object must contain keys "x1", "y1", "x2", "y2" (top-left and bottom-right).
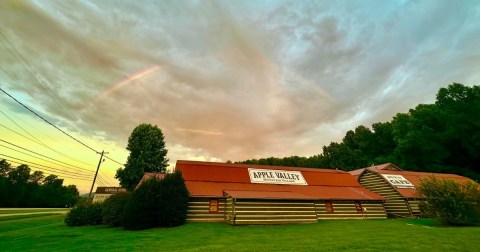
[{"x1": 237, "y1": 83, "x2": 480, "y2": 179}]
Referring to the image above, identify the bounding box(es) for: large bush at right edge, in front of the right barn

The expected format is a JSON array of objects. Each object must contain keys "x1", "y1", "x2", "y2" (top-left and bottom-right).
[{"x1": 417, "y1": 177, "x2": 480, "y2": 226}]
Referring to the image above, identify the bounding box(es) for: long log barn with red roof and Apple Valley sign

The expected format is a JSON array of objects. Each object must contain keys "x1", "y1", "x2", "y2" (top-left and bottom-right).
[{"x1": 172, "y1": 161, "x2": 387, "y2": 225}]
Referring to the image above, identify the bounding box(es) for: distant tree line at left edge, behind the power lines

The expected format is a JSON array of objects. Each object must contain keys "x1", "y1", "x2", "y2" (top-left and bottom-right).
[{"x1": 0, "y1": 159, "x2": 79, "y2": 207}]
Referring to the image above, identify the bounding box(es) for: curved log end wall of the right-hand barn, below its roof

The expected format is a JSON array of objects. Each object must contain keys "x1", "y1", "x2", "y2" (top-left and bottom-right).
[{"x1": 359, "y1": 170, "x2": 412, "y2": 217}]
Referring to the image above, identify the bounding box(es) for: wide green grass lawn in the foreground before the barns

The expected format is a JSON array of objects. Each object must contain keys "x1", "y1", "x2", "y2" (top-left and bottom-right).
[{"x1": 0, "y1": 215, "x2": 480, "y2": 252}]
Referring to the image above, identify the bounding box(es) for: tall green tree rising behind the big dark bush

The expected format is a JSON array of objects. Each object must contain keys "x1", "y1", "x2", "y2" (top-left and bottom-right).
[{"x1": 115, "y1": 123, "x2": 168, "y2": 190}]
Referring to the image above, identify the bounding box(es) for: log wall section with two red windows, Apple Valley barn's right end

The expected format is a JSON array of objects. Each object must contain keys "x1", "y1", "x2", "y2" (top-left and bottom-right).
[{"x1": 315, "y1": 200, "x2": 387, "y2": 220}]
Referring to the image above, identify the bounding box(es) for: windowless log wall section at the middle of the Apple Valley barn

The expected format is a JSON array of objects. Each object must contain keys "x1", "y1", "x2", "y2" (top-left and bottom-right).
[{"x1": 230, "y1": 199, "x2": 317, "y2": 225}]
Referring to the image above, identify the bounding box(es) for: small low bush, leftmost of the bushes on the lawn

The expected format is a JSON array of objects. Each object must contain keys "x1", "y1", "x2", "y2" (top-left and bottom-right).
[{"x1": 65, "y1": 200, "x2": 102, "y2": 226}]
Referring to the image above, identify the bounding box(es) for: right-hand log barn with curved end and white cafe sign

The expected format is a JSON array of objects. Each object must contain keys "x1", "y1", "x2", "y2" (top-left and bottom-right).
[{"x1": 350, "y1": 163, "x2": 473, "y2": 218}]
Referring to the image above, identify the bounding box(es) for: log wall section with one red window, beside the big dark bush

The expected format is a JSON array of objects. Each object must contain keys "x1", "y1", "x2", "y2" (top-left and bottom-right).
[{"x1": 187, "y1": 197, "x2": 225, "y2": 222}]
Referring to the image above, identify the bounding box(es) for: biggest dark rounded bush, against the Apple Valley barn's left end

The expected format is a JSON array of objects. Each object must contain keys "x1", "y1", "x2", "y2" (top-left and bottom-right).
[{"x1": 123, "y1": 172, "x2": 188, "y2": 230}]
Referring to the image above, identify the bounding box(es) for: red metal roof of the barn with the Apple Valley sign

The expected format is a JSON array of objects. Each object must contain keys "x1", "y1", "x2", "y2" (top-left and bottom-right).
[{"x1": 176, "y1": 160, "x2": 384, "y2": 200}]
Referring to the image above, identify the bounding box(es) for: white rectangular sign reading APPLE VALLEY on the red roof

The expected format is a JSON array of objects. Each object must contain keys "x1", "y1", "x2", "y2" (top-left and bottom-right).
[{"x1": 248, "y1": 168, "x2": 308, "y2": 185}]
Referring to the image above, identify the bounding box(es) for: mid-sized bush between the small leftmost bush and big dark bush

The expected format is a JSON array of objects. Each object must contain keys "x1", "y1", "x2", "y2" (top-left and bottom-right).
[{"x1": 102, "y1": 192, "x2": 132, "y2": 227}]
